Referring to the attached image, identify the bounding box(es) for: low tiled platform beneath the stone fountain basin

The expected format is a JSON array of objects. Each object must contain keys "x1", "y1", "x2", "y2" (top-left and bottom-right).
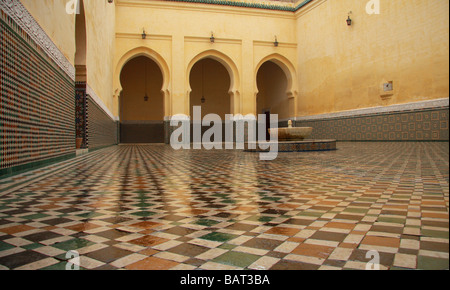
[{"x1": 244, "y1": 140, "x2": 337, "y2": 152}]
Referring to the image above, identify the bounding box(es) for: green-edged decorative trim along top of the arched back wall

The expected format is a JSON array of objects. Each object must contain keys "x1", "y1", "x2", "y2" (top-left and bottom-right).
[{"x1": 163, "y1": 0, "x2": 313, "y2": 12}]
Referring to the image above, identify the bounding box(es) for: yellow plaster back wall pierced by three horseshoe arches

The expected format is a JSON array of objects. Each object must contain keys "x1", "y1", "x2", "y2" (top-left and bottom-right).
[{"x1": 114, "y1": 0, "x2": 297, "y2": 116}]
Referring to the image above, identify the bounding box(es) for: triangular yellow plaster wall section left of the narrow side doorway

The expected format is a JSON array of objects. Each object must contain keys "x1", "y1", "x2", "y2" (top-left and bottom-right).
[{"x1": 21, "y1": 0, "x2": 75, "y2": 65}]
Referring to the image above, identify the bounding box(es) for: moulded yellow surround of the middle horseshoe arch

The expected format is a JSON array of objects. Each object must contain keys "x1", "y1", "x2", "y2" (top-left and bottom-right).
[{"x1": 185, "y1": 49, "x2": 241, "y2": 114}]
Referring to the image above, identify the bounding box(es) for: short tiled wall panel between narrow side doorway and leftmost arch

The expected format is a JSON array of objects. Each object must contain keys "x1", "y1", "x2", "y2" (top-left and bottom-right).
[{"x1": 87, "y1": 95, "x2": 118, "y2": 149}]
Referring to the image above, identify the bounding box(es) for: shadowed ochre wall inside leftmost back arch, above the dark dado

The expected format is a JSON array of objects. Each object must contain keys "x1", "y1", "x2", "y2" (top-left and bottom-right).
[{"x1": 120, "y1": 56, "x2": 164, "y2": 121}]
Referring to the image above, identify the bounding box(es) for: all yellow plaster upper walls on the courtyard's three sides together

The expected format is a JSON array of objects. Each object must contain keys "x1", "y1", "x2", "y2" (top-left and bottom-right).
[{"x1": 22, "y1": 0, "x2": 449, "y2": 117}]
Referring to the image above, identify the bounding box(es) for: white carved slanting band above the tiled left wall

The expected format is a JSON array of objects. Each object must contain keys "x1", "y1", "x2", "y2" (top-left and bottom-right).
[{"x1": 0, "y1": 0, "x2": 75, "y2": 81}]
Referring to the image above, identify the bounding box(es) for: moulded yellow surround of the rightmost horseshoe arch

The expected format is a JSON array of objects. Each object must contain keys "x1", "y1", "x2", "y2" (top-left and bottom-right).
[{"x1": 254, "y1": 53, "x2": 298, "y2": 118}]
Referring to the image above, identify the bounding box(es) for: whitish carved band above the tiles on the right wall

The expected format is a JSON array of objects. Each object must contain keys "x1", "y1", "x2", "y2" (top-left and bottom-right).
[{"x1": 294, "y1": 98, "x2": 449, "y2": 121}]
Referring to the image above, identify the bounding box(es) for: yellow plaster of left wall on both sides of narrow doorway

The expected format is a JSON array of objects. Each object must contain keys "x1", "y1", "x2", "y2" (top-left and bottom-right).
[{"x1": 21, "y1": 0, "x2": 117, "y2": 115}]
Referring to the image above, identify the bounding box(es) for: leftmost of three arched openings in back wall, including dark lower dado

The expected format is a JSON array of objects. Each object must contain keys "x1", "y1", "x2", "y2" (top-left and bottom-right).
[{"x1": 119, "y1": 55, "x2": 164, "y2": 144}]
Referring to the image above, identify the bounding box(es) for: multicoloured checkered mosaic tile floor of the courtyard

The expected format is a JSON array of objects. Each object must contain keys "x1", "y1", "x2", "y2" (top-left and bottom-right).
[{"x1": 0, "y1": 143, "x2": 449, "y2": 270}]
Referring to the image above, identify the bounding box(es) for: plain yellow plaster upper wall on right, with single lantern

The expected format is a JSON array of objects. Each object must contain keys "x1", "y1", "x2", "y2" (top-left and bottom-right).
[{"x1": 297, "y1": 0, "x2": 449, "y2": 116}]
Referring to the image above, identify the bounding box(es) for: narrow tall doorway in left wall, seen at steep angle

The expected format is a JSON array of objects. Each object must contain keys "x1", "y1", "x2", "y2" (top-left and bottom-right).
[{"x1": 75, "y1": 0, "x2": 88, "y2": 149}]
